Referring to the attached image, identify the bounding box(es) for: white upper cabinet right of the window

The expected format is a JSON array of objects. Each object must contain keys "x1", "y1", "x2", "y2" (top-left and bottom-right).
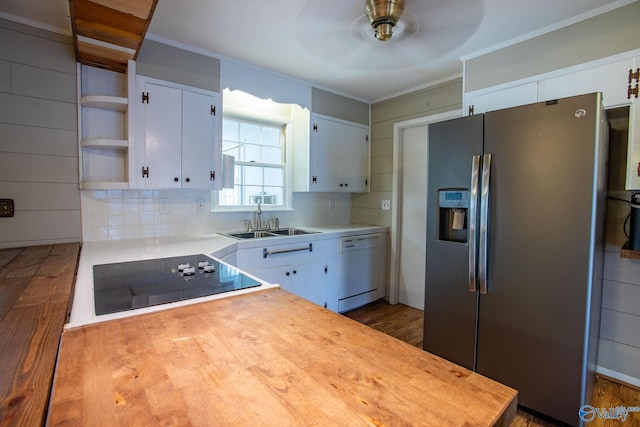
[{"x1": 294, "y1": 114, "x2": 369, "y2": 193}]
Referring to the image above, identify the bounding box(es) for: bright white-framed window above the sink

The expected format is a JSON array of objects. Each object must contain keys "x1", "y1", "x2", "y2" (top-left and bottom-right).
[{"x1": 218, "y1": 116, "x2": 286, "y2": 209}]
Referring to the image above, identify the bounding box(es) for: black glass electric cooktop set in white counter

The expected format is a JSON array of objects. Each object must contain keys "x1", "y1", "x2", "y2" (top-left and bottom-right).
[{"x1": 93, "y1": 254, "x2": 260, "y2": 315}]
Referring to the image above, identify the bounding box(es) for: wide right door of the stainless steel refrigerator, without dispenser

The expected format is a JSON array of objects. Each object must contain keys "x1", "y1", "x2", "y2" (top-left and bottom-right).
[{"x1": 477, "y1": 95, "x2": 605, "y2": 424}]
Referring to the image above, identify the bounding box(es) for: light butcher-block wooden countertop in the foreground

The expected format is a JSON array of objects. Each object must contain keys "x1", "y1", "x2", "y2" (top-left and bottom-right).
[{"x1": 48, "y1": 290, "x2": 517, "y2": 427}]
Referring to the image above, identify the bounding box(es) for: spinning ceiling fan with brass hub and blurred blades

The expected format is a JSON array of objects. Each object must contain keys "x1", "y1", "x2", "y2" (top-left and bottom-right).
[{"x1": 295, "y1": 0, "x2": 484, "y2": 71}]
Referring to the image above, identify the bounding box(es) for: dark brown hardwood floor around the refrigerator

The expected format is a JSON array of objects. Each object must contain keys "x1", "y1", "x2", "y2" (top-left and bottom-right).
[{"x1": 344, "y1": 299, "x2": 640, "y2": 427}]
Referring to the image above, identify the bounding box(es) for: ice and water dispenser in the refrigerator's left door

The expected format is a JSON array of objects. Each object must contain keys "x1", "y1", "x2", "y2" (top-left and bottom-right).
[{"x1": 437, "y1": 189, "x2": 469, "y2": 243}]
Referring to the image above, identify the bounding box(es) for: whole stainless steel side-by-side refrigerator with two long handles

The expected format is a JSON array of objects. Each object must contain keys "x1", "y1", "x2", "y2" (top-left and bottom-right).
[{"x1": 424, "y1": 94, "x2": 608, "y2": 425}]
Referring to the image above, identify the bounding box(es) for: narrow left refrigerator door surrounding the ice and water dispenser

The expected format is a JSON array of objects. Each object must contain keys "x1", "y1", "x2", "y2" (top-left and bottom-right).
[{"x1": 423, "y1": 116, "x2": 483, "y2": 369}]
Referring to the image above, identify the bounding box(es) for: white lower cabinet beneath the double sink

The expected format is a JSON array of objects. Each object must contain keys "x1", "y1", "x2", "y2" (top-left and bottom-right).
[{"x1": 237, "y1": 239, "x2": 338, "y2": 311}]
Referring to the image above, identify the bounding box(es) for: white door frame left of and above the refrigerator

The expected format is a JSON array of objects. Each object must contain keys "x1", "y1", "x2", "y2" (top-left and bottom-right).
[{"x1": 389, "y1": 109, "x2": 463, "y2": 304}]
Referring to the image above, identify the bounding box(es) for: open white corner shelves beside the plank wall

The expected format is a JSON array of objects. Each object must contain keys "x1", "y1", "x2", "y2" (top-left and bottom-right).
[{"x1": 78, "y1": 61, "x2": 135, "y2": 189}]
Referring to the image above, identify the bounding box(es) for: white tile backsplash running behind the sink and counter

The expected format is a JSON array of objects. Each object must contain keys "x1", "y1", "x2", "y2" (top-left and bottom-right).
[{"x1": 81, "y1": 190, "x2": 351, "y2": 241}]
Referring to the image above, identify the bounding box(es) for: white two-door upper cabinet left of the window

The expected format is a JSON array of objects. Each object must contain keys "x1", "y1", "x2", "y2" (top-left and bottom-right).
[{"x1": 138, "y1": 78, "x2": 222, "y2": 190}]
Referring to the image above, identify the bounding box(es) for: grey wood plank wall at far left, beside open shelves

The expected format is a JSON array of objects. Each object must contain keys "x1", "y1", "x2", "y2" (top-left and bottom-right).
[{"x1": 0, "y1": 19, "x2": 82, "y2": 248}]
